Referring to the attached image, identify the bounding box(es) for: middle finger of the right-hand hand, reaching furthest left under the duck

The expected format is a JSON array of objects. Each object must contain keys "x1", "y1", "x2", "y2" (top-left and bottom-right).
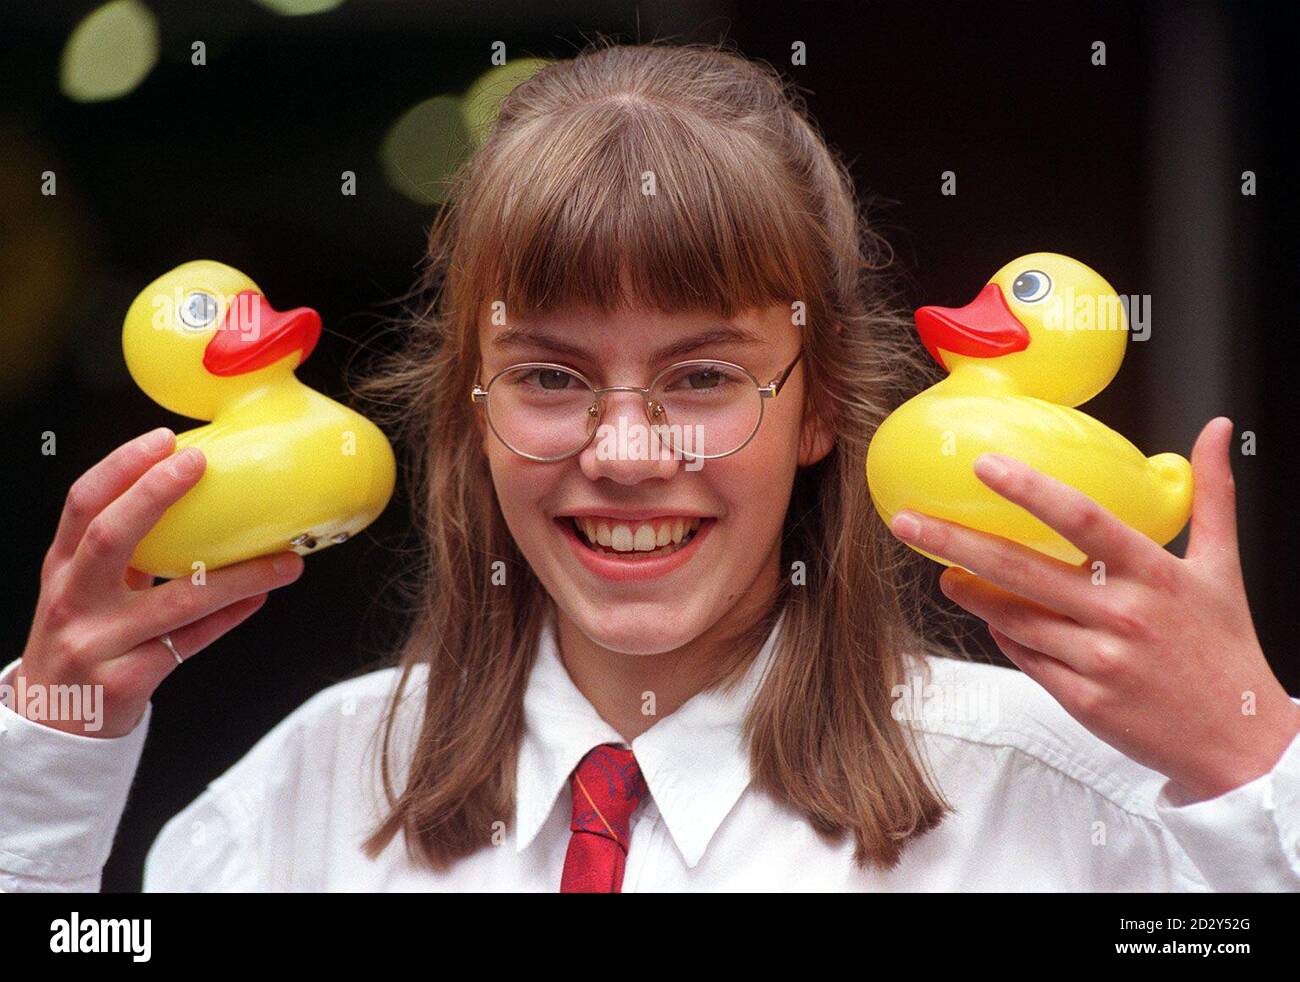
[{"x1": 891, "y1": 510, "x2": 1105, "y2": 624}]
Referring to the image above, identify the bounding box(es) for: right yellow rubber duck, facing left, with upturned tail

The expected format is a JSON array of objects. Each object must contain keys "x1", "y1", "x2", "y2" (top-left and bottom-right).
[{"x1": 867, "y1": 252, "x2": 1192, "y2": 566}]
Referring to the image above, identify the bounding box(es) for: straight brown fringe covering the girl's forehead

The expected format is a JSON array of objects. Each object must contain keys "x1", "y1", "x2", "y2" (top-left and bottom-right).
[{"x1": 454, "y1": 99, "x2": 815, "y2": 317}]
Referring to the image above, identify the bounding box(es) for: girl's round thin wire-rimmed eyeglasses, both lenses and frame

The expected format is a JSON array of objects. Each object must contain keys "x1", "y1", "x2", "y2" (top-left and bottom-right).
[{"x1": 469, "y1": 350, "x2": 803, "y2": 462}]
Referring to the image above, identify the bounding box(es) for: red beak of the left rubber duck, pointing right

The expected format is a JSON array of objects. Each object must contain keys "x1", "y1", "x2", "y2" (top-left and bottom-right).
[{"x1": 203, "y1": 290, "x2": 321, "y2": 375}]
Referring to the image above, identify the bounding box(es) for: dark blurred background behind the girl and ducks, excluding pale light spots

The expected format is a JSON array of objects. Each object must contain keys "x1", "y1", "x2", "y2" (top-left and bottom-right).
[{"x1": 0, "y1": 0, "x2": 1300, "y2": 890}]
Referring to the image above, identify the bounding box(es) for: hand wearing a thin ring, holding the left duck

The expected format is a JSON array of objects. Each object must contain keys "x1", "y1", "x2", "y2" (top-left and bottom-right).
[{"x1": 12, "y1": 428, "x2": 303, "y2": 737}]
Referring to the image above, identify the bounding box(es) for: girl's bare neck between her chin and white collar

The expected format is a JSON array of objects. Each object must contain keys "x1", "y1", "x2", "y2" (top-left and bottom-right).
[{"x1": 555, "y1": 541, "x2": 780, "y2": 743}]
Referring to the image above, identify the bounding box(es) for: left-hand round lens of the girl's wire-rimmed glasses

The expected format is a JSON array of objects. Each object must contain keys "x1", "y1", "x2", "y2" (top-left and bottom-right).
[{"x1": 488, "y1": 365, "x2": 595, "y2": 457}]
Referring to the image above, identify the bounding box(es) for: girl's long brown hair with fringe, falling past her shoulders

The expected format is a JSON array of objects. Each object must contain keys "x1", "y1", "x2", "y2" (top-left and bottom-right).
[{"x1": 359, "y1": 39, "x2": 948, "y2": 868}]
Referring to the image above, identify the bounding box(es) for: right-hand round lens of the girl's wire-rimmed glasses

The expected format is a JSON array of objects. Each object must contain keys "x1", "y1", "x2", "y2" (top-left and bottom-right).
[{"x1": 650, "y1": 362, "x2": 763, "y2": 457}]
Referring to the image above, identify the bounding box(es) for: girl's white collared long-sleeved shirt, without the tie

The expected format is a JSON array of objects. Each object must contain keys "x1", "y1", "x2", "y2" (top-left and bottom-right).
[{"x1": 0, "y1": 613, "x2": 1300, "y2": 892}]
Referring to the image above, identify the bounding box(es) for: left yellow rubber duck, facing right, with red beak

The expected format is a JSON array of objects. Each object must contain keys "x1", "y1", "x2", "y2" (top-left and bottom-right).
[{"x1": 122, "y1": 260, "x2": 397, "y2": 579}]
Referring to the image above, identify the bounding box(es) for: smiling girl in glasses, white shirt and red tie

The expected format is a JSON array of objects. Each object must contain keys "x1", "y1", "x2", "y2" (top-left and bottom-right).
[{"x1": 0, "y1": 38, "x2": 1300, "y2": 891}]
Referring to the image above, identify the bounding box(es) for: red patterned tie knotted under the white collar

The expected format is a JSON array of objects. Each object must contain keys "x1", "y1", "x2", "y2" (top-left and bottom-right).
[{"x1": 560, "y1": 744, "x2": 646, "y2": 894}]
